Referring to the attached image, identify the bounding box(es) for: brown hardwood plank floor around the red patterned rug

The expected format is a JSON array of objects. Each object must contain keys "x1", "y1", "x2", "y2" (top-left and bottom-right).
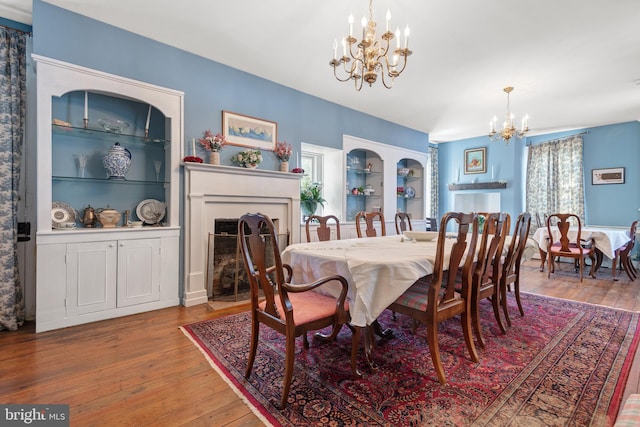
[{"x1": 0, "y1": 260, "x2": 640, "y2": 426}]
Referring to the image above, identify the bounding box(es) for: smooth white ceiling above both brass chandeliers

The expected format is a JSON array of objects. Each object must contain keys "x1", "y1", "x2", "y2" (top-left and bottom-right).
[{"x1": 0, "y1": 0, "x2": 640, "y2": 142}]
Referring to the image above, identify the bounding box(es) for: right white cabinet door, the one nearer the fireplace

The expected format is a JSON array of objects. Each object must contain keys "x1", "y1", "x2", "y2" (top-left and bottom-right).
[{"x1": 118, "y1": 239, "x2": 160, "y2": 307}]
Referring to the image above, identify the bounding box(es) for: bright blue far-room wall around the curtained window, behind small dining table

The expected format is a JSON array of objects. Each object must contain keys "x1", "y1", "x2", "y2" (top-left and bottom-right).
[{"x1": 438, "y1": 122, "x2": 640, "y2": 227}]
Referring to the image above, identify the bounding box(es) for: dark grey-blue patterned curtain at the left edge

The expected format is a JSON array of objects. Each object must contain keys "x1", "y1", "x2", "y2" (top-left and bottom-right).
[{"x1": 0, "y1": 27, "x2": 27, "y2": 330}]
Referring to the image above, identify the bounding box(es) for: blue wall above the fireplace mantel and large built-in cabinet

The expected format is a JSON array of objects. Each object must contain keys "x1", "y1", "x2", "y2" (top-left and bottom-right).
[{"x1": 33, "y1": 0, "x2": 429, "y2": 170}]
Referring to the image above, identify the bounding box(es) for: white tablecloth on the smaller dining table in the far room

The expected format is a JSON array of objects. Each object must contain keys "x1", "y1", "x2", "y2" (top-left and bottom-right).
[{"x1": 533, "y1": 227, "x2": 631, "y2": 259}]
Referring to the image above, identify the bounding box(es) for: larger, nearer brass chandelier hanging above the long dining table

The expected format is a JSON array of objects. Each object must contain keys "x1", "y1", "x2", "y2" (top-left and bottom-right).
[{"x1": 329, "y1": 0, "x2": 412, "y2": 91}]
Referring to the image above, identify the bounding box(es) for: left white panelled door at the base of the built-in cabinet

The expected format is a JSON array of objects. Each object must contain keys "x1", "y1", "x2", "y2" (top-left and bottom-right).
[{"x1": 66, "y1": 241, "x2": 117, "y2": 316}]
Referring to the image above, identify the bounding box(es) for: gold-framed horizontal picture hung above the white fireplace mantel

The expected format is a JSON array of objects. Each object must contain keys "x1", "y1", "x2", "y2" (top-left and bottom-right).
[{"x1": 222, "y1": 111, "x2": 278, "y2": 151}]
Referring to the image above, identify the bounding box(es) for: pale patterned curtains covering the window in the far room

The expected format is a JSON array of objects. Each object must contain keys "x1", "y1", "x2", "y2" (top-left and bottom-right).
[{"x1": 526, "y1": 135, "x2": 584, "y2": 223}]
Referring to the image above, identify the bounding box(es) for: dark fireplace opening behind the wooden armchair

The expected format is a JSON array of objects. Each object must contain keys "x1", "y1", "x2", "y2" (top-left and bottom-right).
[{"x1": 207, "y1": 218, "x2": 289, "y2": 301}]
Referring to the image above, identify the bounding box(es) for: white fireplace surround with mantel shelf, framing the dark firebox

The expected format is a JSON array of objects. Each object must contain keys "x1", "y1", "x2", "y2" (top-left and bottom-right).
[{"x1": 181, "y1": 163, "x2": 301, "y2": 307}]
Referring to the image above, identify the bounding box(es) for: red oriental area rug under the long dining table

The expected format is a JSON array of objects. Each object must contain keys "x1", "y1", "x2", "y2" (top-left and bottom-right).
[{"x1": 182, "y1": 294, "x2": 640, "y2": 426}]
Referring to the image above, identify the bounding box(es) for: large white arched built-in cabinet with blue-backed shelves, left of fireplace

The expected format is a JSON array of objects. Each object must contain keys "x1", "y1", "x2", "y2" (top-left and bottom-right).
[{"x1": 33, "y1": 55, "x2": 184, "y2": 332}]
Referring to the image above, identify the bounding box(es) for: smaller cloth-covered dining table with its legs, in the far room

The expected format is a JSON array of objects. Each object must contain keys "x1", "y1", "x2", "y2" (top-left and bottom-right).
[{"x1": 533, "y1": 226, "x2": 631, "y2": 278}]
